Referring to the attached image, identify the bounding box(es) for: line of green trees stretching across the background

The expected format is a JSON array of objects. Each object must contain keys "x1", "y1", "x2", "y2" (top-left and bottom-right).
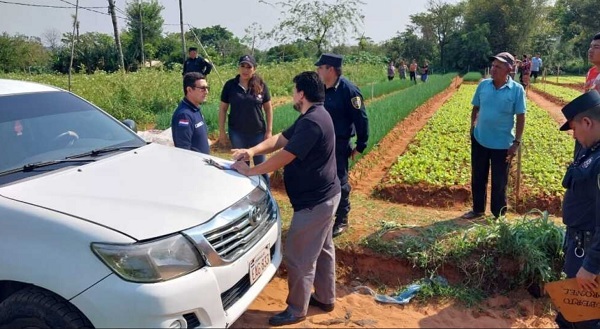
[{"x1": 0, "y1": 0, "x2": 600, "y2": 73}]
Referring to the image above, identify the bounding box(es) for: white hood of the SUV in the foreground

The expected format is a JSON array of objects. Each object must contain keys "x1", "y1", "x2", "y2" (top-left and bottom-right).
[{"x1": 0, "y1": 144, "x2": 258, "y2": 240}]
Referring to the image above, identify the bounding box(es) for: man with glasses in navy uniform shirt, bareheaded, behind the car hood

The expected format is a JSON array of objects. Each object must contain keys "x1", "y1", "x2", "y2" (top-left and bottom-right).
[{"x1": 171, "y1": 72, "x2": 210, "y2": 154}]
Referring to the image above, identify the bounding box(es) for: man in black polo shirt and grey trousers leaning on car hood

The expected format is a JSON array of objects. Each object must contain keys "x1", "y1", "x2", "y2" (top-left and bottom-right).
[{"x1": 233, "y1": 72, "x2": 340, "y2": 326}]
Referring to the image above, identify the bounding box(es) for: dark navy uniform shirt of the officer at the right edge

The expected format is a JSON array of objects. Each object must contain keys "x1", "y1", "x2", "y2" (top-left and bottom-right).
[{"x1": 562, "y1": 146, "x2": 600, "y2": 274}]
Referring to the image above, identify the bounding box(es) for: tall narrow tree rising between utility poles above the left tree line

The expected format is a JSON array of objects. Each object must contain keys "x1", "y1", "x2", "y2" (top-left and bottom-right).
[{"x1": 122, "y1": 0, "x2": 164, "y2": 62}]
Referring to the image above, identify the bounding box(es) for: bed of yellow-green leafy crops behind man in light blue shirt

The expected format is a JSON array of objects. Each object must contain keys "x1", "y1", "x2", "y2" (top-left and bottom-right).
[{"x1": 377, "y1": 85, "x2": 574, "y2": 211}]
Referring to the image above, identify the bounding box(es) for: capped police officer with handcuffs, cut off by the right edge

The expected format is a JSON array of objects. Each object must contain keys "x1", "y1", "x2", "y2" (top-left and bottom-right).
[{"x1": 556, "y1": 91, "x2": 600, "y2": 328}]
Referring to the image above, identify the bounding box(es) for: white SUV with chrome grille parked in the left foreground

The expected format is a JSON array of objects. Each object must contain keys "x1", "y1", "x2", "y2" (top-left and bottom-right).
[{"x1": 0, "y1": 79, "x2": 281, "y2": 328}]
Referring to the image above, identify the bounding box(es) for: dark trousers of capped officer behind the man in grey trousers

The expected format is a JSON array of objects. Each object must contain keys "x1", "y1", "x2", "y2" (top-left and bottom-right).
[{"x1": 335, "y1": 138, "x2": 352, "y2": 224}]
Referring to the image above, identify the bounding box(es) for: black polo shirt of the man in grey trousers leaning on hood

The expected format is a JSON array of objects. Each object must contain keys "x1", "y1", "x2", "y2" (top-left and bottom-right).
[{"x1": 282, "y1": 104, "x2": 341, "y2": 211}]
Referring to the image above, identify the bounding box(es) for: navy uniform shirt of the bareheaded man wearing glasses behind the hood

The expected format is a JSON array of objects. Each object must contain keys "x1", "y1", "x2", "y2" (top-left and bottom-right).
[{"x1": 171, "y1": 98, "x2": 210, "y2": 154}]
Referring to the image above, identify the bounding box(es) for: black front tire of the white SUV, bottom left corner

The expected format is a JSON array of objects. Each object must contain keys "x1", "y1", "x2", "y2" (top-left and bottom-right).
[{"x1": 0, "y1": 287, "x2": 94, "y2": 329}]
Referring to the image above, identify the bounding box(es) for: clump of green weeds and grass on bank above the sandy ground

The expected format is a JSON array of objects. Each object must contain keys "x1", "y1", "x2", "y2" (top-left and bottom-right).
[{"x1": 361, "y1": 211, "x2": 564, "y2": 303}]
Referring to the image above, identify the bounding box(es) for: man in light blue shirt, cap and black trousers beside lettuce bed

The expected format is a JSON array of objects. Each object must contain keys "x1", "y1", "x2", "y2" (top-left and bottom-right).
[{"x1": 462, "y1": 52, "x2": 526, "y2": 219}]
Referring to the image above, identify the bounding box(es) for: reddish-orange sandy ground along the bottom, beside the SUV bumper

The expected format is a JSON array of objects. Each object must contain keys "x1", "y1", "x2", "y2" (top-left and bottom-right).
[{"x1": 232, "y1": 277, "x2": 556, "y2": 328}]
